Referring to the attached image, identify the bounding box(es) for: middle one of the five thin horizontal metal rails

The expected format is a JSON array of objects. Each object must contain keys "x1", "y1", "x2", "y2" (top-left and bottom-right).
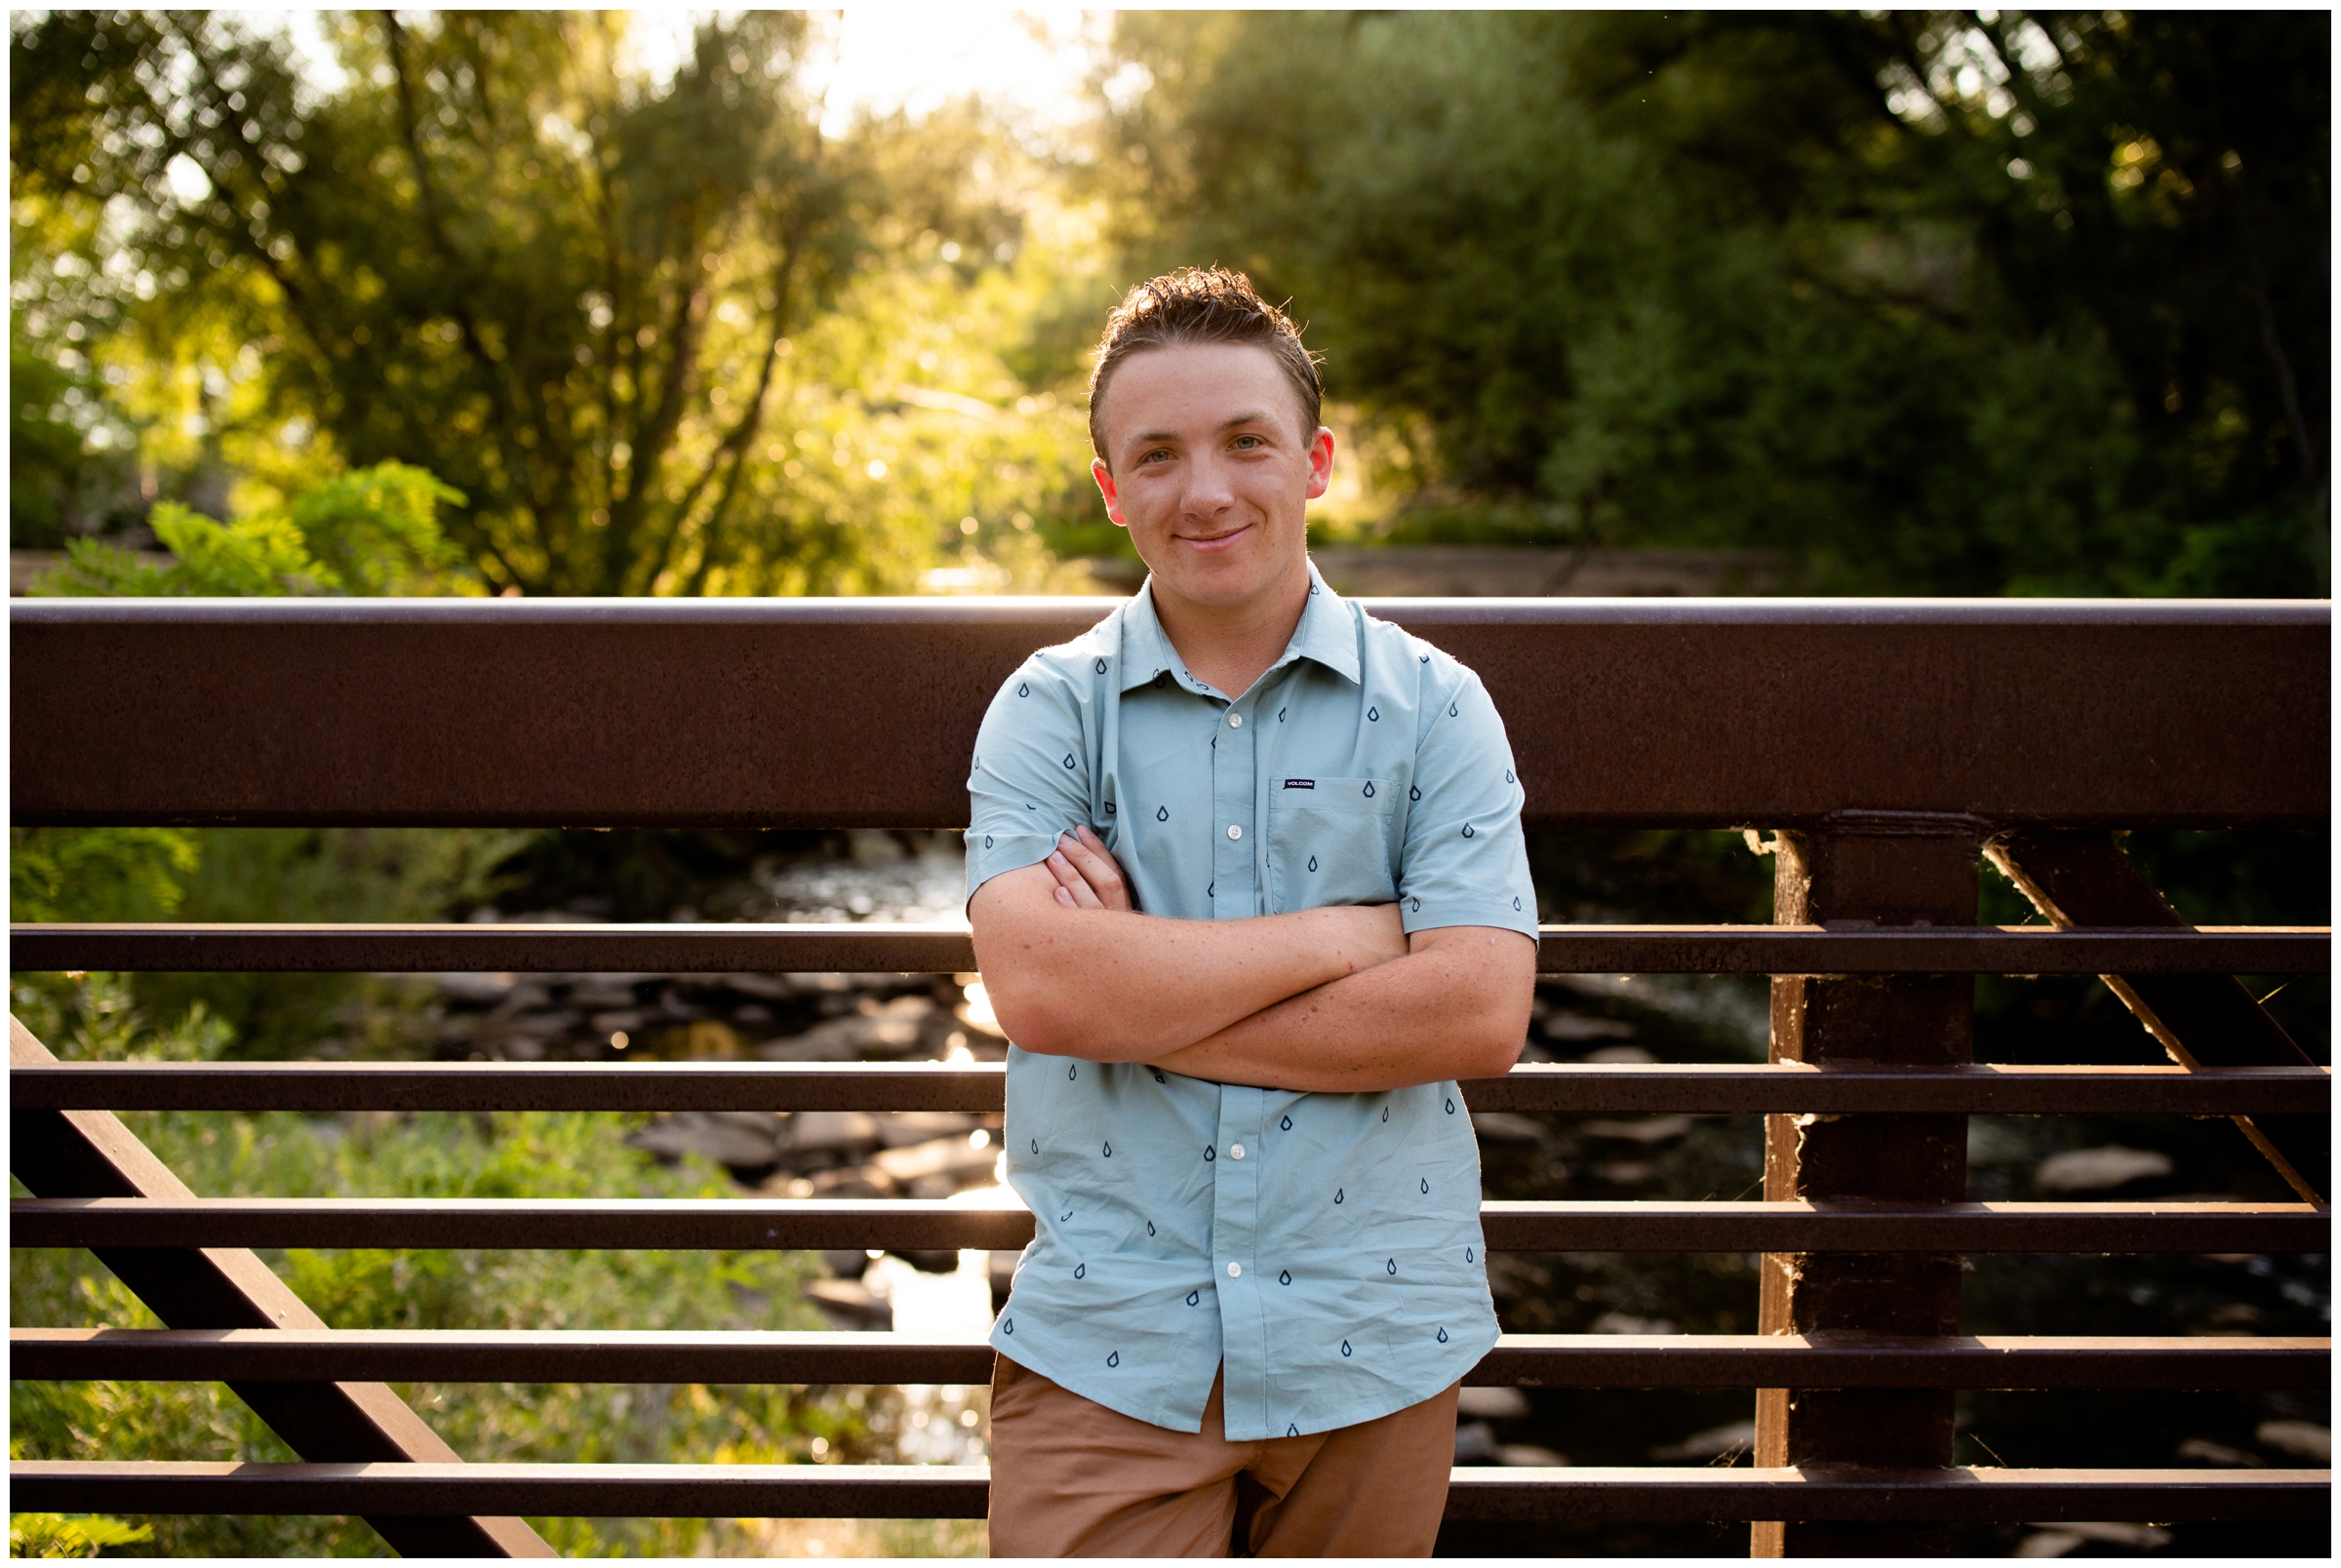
[{"x1": 10, "y1": 1189, "x2": 2331, "y2": 1252}]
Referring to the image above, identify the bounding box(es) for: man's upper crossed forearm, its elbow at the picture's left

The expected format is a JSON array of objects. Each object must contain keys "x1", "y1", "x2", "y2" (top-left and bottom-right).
[{"x1": 972, "y1": 873, "x2": 1398, "y2": 1063}]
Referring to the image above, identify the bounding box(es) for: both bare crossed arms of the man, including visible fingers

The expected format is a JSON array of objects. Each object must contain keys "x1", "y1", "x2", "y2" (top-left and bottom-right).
[{"x1": 967, "y1": 829, "x2": 1535, "y2": 1093}]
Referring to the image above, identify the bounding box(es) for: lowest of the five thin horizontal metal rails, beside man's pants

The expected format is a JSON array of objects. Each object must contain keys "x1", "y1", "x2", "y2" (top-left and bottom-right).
[{"x1": 10, "y1": 1461, "x2": 2331, "y2": 1523}]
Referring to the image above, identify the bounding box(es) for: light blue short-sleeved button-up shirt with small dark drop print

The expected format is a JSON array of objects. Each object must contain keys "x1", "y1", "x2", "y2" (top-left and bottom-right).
[{"x1": 967, "y1": 567, "x2": 1535, "y2": 1441}]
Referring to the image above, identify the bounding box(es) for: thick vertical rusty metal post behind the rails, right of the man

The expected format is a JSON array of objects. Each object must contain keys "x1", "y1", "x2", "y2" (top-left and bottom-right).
[{"x1": 1749, "y1": 812, "x2": 1983, "y2": 1556}]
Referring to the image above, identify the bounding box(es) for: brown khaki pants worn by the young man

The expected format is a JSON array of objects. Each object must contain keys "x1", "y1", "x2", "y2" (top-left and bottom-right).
[{"x1": 990, "y1": 1355, "x2": 1456, "y2": 1556}]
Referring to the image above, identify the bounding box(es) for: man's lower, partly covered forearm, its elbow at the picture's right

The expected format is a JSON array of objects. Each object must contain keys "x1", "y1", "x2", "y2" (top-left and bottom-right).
[{"x1": 1152, "y1": 926, "x2": 1535, "y2": 1093}]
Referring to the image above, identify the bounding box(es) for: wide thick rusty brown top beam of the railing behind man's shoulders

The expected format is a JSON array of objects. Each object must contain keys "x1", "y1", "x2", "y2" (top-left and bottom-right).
[{"x1": 10, "y1": 599, "x2": 2331, "y2": 829}]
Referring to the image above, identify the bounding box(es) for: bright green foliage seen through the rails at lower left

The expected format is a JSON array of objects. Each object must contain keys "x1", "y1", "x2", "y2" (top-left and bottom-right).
[{"x1": 10, "y1": 976, "x2": 871, "y2": 1556}]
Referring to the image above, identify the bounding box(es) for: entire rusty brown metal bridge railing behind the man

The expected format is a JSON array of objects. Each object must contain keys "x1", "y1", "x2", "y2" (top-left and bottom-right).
[{"x1": 10, "y1": 599, "x2": 2329, "y2": 1556}]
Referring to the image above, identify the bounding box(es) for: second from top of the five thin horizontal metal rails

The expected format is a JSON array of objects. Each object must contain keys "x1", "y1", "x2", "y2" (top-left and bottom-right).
[{"x1": 10, "y1": 1060, "x2": 2331, "y2": 1117}]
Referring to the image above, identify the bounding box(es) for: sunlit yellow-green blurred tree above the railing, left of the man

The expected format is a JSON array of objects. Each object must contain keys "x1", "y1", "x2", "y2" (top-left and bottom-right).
[{"x1": 12, "y1": 12, "x2": 1053, "y2": 595}]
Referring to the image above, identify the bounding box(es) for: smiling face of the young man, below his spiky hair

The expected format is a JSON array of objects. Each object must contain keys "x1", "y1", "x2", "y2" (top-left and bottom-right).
[{"x1": 1091, "y1": 344, "x2": 1332, "y2": 610}]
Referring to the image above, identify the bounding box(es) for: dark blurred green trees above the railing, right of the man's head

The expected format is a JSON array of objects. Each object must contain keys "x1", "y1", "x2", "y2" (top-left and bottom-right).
[{"x1": 1093, "y1": 12, "x2": 2329, "y2": 595}]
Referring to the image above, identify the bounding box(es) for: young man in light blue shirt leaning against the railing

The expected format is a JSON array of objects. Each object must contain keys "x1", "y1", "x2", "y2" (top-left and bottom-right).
[{"x1": 967, "y1": 269, "x2": 1535, "y2": 1556}]
